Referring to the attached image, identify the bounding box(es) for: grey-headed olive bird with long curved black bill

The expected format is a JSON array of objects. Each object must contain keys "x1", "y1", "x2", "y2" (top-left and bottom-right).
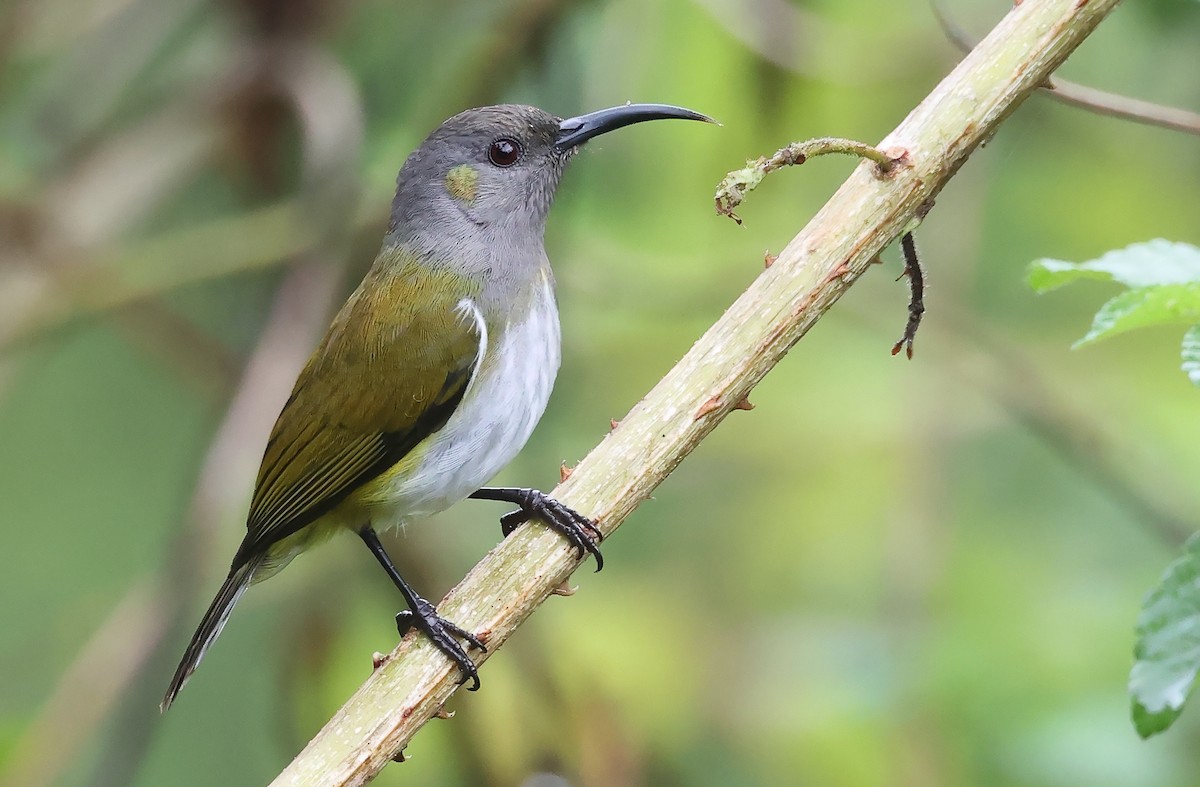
[{"x1": 160, "y1": 103, "x2": 715, "y2": 711}]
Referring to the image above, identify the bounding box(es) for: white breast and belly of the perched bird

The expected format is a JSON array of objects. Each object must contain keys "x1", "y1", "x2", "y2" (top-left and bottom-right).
[{"x1": 380, "y1": 276, "x2": 560, "y2": 515}]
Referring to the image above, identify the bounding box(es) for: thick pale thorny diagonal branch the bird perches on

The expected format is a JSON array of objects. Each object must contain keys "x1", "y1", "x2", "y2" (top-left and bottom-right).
[{"x1": 274, "y1": 0, "x2": 1117, "y2": 786}]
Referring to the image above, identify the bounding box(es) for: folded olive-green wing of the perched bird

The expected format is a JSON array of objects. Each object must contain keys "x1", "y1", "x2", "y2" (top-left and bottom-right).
[{"x1": 234, "y1": 265, "x2": 486, "y2": 567}]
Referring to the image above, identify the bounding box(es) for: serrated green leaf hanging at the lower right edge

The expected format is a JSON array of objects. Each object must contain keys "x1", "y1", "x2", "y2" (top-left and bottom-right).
[{"x1": 1129, "y1": 536, "x2": 1200, "y2": 738}]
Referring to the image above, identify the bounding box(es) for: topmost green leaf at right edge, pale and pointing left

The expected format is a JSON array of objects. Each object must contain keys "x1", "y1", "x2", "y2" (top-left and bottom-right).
[{"x1": 1028, "y1": 238, "x2": 1200, "y2": 293}]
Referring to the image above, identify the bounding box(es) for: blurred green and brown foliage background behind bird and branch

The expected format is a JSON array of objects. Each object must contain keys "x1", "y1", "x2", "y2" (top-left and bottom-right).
[{"x1": 0, "y1": 0, "x2": 1200, "y2": 787}]
